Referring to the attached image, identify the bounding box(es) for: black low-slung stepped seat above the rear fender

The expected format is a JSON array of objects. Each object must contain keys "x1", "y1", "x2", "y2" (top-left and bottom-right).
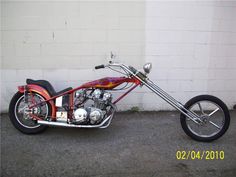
[{"x1": 26, "y1": 79, "x2": 72, "y2": 96}]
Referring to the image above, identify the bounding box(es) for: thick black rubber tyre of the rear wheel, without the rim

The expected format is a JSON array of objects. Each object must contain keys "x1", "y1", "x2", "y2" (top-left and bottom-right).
[{"x1": 9, "y1": 92, "x2": 52, "y2": 134}]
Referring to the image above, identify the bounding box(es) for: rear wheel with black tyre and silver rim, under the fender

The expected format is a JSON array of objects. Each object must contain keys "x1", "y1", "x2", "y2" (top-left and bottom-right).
[{"x1": 9, "y1": 92, "x2": 51, "y2": 134}]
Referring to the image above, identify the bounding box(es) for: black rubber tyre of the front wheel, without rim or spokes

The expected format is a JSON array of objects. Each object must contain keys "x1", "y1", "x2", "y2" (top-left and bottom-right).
[{"x1": 180, "y1": 95, "x2": 230, "y2": 142}]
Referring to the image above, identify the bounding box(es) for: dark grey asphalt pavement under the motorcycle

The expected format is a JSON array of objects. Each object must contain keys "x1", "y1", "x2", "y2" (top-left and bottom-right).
[{"x1": 1, "y1": 111, "x2": 236, "y2": 177}]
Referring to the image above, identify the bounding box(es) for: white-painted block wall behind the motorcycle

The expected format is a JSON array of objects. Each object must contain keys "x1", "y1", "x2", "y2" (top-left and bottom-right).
[{"x1": 0, "y1": 0, "x2": 236, "y2": 111}]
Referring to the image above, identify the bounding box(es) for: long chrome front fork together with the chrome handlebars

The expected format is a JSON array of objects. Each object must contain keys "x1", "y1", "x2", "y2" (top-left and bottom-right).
[{"x1": 105, "y1": 61, "x2": 202, "y2": 124}]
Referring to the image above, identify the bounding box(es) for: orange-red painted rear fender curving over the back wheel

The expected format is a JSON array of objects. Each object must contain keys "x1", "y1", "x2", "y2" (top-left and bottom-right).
[{"x1": 18, "y1": 84, "x2": 56, "y2": 117}]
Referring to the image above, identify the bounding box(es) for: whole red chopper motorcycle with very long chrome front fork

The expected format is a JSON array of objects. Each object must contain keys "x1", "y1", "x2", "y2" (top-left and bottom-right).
[{"x1": 9, "y1": 57, "x2": 230, "y2": 142}]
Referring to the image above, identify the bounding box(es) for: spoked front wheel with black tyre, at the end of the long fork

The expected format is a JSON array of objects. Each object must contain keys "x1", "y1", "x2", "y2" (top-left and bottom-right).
[{"x1": 180, "y1": 95, "x2": 230, "y2": 142}]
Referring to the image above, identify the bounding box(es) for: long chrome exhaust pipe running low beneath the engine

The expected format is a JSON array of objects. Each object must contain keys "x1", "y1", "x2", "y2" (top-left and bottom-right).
[{"x1": 38, "y1": 114, "x2": 113, "y2": 128}]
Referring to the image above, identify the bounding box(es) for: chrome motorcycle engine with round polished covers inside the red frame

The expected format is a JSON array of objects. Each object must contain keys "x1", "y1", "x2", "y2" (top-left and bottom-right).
[{"x1": 74, "y1": 89, "x2": 112, "y2": 124}]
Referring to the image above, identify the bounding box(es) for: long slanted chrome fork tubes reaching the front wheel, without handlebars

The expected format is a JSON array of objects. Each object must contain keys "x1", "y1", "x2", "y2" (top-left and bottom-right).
[{"x1": 142, "y1": 79, "x2": 202, "y2": 125}]
